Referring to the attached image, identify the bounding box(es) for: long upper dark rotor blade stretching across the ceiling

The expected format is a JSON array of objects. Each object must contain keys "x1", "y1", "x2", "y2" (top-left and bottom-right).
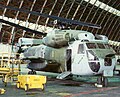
[{"x1": 0, "y1": 4, "x2": 101, "y2": 29}]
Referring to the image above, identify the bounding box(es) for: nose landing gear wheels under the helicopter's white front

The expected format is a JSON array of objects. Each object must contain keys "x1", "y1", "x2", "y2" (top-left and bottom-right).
[{"x1": 96, "y1": 76, "x2": 108, "y2": 87}]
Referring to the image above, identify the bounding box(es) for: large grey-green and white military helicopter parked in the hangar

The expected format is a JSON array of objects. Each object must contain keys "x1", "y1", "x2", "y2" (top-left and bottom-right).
[{"x1": 0, "y1": 5, "x2": 115, "y2": 86}]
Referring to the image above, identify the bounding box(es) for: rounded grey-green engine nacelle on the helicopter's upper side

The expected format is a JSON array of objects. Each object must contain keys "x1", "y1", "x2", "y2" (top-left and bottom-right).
[{"x1": 43, "y1": 30, "x2": 70, "y2": 48}]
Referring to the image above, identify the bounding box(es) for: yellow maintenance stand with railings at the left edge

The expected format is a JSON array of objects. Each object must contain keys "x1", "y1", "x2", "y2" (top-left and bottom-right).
[{"x1": 0, "y1": 53, "x2": 21, "y2": 86}]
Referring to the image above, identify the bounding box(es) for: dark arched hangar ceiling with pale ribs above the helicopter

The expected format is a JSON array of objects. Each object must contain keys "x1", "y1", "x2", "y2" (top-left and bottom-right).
[{"x1": 0, "y1": 0, "x2": 120, "y2": 53}]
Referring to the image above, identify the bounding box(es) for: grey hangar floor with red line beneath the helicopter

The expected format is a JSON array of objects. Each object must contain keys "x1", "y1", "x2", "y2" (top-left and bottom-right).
[{"x1": 0, "y1": 64, "x2": 120, "y2": 97}]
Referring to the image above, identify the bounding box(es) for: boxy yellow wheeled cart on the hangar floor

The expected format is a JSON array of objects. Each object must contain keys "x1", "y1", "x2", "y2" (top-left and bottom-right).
[{"x1": 17, "y1": 75, "x2": 46, "y2": 91}]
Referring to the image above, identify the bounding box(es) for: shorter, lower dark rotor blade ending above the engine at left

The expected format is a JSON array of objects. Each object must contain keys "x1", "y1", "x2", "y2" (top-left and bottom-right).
[{"x1": 0, "y1": 19, "x2": 47, "y2": 36}]
